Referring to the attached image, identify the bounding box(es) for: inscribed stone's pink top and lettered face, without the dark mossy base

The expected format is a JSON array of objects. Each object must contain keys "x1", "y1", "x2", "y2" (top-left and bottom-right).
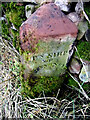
[{"x1": 20, "y1": 3, "x2": 77, "y2": 76}]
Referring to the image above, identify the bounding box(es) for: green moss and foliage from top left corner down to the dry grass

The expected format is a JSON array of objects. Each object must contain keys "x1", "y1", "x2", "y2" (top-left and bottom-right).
[{"x1": 2, "y1": 2, "x2": 25, "y2": 50}]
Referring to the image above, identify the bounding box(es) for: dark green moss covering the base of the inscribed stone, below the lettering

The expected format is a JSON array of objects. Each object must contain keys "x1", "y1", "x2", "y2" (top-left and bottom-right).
[{"x1": 22, "y1": 76, "x2": 64, "y2": 97}]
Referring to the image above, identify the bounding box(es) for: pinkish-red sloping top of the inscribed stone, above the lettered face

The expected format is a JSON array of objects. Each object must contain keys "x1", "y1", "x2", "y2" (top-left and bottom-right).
[{"x1": 20, "y1": 3, "x2": 78, "y2": 50}]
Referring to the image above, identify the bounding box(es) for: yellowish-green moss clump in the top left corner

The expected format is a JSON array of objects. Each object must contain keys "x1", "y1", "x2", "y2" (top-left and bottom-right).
[{"x1": 2, "y1": 2, "x2": 25, "y2": 29}]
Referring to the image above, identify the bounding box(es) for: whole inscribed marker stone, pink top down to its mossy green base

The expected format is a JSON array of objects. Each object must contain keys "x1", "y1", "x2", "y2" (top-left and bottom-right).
[{"x1": 20, "y1": 3, "x2": 78, "y2": 96}]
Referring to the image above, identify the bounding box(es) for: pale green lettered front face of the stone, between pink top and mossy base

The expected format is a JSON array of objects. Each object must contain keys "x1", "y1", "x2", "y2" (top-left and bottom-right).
[{"x1": 23, "y1": 41, "x2": 71, "y2": 76}]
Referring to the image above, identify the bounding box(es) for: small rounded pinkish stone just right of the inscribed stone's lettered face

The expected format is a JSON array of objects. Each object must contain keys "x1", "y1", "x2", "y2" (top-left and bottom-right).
[{"x1": 69, "y1": 58, "x2": 81, "y2": 74}]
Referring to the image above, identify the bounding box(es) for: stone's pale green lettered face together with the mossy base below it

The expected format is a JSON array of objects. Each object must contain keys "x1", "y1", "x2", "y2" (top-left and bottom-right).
[{"x1": 21, "y1": 37, "x2": 74, "y2": 97}]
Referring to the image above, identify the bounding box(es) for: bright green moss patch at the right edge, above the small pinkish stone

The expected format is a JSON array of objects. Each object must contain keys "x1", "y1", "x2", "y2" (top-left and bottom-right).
[{"x1": 75, "y1": 41, "x2": 90, "y2": 61}]
